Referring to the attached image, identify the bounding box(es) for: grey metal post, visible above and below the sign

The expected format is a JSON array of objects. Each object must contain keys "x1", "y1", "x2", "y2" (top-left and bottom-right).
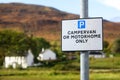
[{"x1": 80, "y1": 0, "x2": 89, "y2": 80}]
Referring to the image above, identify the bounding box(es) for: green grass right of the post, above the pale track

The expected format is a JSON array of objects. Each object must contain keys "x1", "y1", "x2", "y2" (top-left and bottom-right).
[{"x1": 90, "y1": 57, "x2": 120, "y2": 69}]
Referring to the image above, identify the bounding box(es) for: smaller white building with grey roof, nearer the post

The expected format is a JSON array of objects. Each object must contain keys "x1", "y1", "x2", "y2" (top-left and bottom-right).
[{"x1": 37, "y1": 49, "x2": 56, "y2": 61}]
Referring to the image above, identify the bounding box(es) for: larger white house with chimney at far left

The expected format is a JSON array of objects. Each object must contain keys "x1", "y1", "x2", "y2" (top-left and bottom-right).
[{"x1": 4, "y1": 50, "x2": 34, "y2": 68}]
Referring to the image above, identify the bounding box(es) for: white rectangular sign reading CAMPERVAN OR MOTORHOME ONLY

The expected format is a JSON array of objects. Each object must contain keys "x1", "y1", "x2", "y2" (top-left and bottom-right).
[{"x1": 62, "y1": 18, "x2": 103, "y2": 51}]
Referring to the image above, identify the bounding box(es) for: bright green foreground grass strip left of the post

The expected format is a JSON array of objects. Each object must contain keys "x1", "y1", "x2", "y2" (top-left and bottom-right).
[{"x1": 0, "y1": 68, "x2": 79, "y2": 80}]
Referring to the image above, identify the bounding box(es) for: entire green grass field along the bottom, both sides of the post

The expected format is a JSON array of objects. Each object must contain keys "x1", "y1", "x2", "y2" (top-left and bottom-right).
[{"x1": 0, "y1": 57, "x2": 120, "y2": 80}]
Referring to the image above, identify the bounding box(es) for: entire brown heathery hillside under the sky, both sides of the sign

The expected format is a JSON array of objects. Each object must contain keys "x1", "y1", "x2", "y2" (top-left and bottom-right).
[{"x1": 0, "y1": 3, "x2": 120, "y2": 41}]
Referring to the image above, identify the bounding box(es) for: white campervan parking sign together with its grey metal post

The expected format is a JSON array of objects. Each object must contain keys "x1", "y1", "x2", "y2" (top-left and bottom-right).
[{"x1": 62, "y1": 0, "x2": 103, "y2": 80}]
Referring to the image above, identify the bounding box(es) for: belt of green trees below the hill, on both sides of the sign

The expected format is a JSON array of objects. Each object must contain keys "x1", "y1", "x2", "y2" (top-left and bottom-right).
[{"x1": 0, "y1": 30, "x2": 120, "y2": 65}]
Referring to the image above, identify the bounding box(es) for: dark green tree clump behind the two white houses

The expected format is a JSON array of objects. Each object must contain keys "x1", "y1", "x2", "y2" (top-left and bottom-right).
[{"x1": 0, "y1": 30, "x2": 50, "y2": 61}]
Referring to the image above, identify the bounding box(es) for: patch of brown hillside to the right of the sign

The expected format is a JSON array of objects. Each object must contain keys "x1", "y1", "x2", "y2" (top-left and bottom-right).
[{"x1": 103, "y1": 21, "x2": 120, "y2": 42}]
